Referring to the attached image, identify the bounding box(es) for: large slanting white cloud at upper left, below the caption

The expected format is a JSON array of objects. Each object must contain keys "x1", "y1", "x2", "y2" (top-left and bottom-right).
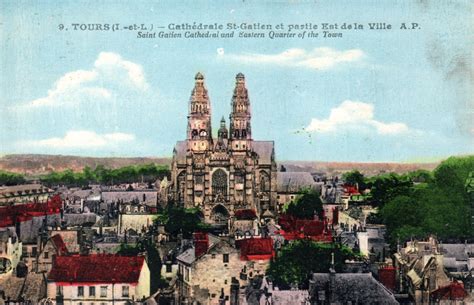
[{"x1": 16, "y1": 52, "x2": 148, "y2": 110}]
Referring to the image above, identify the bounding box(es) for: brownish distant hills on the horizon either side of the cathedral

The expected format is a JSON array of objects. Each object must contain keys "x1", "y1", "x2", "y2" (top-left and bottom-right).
[{"x1": 0, "y1": 154, "x2": 439, "y2": 176}]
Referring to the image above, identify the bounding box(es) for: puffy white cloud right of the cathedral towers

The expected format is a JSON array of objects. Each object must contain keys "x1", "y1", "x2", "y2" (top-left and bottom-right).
[{"x1": 305, "y1": 100, "x2": 409, "y2": 135}]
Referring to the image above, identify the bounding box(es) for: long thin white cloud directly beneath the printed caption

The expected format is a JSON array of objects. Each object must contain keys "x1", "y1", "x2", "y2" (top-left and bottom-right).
[{"x1": 225, "y1": 47, "x2": 365, "y2": 70}]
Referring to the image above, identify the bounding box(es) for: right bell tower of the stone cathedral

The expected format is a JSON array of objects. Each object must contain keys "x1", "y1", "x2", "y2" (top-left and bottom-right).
[{"x1": 229, "y1": 73, "x2": 252, "y2": 151}]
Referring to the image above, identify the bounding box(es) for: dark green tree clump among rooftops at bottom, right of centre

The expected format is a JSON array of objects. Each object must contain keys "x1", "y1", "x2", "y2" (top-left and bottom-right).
[{"x1": 267, "y1": 240, "x2": 357, "y2": 289}]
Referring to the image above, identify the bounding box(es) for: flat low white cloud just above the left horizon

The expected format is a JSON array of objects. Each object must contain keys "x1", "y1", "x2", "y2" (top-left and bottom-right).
[{"x1": 20, "y1": 130, "x2": 135, "y2": 149}]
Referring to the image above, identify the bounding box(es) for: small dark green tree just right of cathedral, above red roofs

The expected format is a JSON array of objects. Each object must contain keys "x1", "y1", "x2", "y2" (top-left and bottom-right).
[{"x1": 285, "y1": 189, "x2": 323, "y2": 219}]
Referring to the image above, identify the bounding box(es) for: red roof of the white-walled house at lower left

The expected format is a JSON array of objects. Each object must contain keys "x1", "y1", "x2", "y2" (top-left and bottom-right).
[{"x1": 48, "y1": 254, "x2": 145, "y2": 283}]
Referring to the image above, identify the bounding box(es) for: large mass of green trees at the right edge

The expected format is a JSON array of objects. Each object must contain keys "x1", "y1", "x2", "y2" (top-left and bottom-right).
[{"x1": 380, "y1": 156, "x2": 474, "y2": 248}]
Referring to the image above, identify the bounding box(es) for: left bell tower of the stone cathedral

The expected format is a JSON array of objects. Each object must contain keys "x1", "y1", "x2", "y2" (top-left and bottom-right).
[{"x1": 187, "y1": 72, "x2": 212, "y2": 151}]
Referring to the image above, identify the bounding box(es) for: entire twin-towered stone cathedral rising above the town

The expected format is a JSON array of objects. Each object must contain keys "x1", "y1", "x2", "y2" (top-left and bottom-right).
[{"x1": 171, "y1": 73, "x2": 277, "y2": 225}]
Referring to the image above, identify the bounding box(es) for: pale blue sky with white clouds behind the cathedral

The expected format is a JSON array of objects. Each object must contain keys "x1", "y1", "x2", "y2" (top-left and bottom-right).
[{"x1": 0, "y1": 1, "x2": 474, "y2": 162}]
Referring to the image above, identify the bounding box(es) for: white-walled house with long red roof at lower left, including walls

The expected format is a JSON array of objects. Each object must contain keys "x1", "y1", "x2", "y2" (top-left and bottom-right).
[{"x1": 47, "y1": 255, "x2": 150, "y2": 305}]
